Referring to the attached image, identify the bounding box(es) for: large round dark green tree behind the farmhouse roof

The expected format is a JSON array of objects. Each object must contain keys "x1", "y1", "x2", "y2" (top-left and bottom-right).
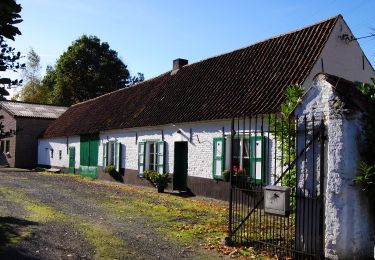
[{"x1": 42, "y1": 35, "x2": 129, "y2": 106}]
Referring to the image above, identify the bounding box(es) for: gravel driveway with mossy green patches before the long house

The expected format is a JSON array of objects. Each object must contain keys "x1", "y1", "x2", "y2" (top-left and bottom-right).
[{"x1": 0, "y1": 171, "x2": 227, "y2": 259}]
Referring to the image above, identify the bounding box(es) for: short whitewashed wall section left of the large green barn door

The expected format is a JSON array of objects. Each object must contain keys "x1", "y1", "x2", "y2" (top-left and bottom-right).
[{"x1": 38, "y1": 136, "x2": 80, "y2": 169}]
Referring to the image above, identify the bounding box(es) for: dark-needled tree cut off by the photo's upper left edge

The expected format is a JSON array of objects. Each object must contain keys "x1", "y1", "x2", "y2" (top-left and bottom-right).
[{"x1": 0, "y1": 0, "x2": 24, "y2": 99}]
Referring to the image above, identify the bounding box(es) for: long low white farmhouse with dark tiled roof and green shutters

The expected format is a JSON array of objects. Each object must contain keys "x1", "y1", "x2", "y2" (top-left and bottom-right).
[{"x1": 38, "y1": 15, "x2": 375, "y2": 199}]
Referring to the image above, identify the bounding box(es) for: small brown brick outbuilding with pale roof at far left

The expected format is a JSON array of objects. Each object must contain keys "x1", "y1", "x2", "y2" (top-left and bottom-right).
[{"x1": 0, "y1": 100, "x2": 67, "y2": 169}]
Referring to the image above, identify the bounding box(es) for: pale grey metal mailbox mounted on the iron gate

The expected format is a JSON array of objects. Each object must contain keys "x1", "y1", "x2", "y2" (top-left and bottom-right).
[{"x1": 264, "y1": 185, "x2": 290, "y2": 217}]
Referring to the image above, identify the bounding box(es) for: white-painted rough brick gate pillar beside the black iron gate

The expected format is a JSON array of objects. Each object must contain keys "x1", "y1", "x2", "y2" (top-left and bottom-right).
[{"x1": 296, "y1": 75, "x2": 375, "y2": 259}]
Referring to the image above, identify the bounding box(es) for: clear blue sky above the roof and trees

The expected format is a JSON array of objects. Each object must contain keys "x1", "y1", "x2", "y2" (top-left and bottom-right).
[{"x1": 3, "y1": 0, "x2": 375, "y2": 94}]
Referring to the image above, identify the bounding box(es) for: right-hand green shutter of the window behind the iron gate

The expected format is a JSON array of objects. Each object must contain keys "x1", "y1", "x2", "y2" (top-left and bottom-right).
[{"x1": 250, "y1": 136, "x2": 266, "y2": 184}]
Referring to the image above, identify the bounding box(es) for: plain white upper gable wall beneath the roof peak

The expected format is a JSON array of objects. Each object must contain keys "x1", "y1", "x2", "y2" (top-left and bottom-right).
[{"x1": 303, "y1": 18, "x2": 375, "y2": 89}]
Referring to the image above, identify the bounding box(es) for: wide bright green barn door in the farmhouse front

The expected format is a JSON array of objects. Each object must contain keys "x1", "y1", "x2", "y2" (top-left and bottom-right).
[{"x1": 79, "y1": 135, "x2": 99, "y2": 179}]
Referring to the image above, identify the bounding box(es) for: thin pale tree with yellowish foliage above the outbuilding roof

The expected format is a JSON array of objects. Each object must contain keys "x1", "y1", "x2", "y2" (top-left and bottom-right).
[{"x1": 12, "y1": 48, "x2": 48, "y2": 103}]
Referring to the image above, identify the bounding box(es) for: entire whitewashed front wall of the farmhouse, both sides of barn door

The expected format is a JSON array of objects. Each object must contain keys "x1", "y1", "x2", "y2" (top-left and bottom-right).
[{"x1": 38, "y1": 120, "x2": 281, "y2": 183}]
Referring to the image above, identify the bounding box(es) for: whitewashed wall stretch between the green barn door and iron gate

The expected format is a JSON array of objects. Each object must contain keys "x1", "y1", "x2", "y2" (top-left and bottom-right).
[{"x1": 98, "y1": 120, "x2": 235, "y2": 178}]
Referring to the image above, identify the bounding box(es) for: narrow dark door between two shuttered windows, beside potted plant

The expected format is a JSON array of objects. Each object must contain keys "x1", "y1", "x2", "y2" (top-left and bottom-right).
[{"x1": 173, "y1": 142, "x2": 188, "y2": 190}]
